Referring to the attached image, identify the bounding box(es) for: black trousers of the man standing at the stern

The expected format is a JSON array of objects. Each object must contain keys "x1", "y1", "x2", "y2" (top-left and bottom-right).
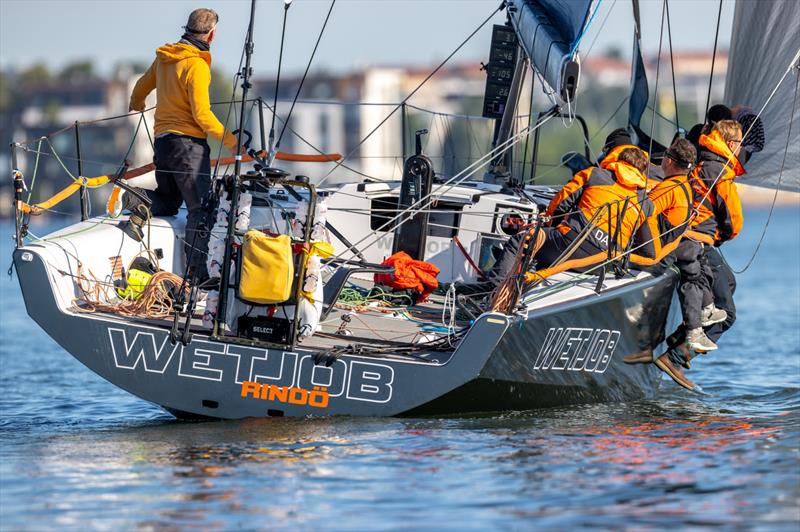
[{"x1": 147, "y1": 134, "x2": 211, "y2": 280}]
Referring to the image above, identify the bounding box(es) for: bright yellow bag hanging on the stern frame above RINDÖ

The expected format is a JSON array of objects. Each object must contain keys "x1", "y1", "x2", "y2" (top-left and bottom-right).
[{"x1": 239, "y1": 229, "x2": 294, "y2": 305}]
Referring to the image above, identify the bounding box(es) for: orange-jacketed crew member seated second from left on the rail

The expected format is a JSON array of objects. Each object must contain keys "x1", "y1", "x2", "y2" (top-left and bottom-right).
[{"x1": 630, "y1": 138, "x2": 697, "y2": 274}]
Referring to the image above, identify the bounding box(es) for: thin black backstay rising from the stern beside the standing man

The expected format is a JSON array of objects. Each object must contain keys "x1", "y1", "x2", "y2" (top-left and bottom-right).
[{"x1": 214, "y1": 0, "x2": 258, "y2": 336}]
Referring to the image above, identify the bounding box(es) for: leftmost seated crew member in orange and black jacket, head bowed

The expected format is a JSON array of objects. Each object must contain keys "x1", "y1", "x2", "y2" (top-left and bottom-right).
[{"x1": 536, "y1": 145, "x2": 652, "y2": 272}]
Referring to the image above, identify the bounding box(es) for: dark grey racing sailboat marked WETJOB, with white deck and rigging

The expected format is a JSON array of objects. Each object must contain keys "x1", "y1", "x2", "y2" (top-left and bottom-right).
[{"x1": 7, "y1": 0, "x2": 800, "y2": 419}]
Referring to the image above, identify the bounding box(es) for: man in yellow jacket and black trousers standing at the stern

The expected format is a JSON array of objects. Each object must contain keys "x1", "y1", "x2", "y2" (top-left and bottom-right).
[{"x1": 123, "y1": 9, "x2": 236, "y2": 279}]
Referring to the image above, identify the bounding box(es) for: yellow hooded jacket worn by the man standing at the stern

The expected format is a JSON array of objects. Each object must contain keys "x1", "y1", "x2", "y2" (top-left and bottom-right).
[{"x1": 130, "y1": 43, "x2": 236, "y2": 148}]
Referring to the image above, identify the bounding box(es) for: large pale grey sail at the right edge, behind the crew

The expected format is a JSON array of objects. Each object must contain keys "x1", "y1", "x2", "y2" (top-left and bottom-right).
[{"x1": 725, "y1": 0, "x2": 800, "y2": 191}]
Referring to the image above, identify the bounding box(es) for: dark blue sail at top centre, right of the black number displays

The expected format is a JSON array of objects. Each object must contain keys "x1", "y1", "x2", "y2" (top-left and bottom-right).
[{"x1": 507, "y1": 0, "x2": 592, "y2": 99}]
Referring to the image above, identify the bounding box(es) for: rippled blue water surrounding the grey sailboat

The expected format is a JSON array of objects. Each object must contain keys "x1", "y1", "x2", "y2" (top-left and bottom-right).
[{"x1": 0, "y1": 208, "x2": 800, "y2": 530}]
